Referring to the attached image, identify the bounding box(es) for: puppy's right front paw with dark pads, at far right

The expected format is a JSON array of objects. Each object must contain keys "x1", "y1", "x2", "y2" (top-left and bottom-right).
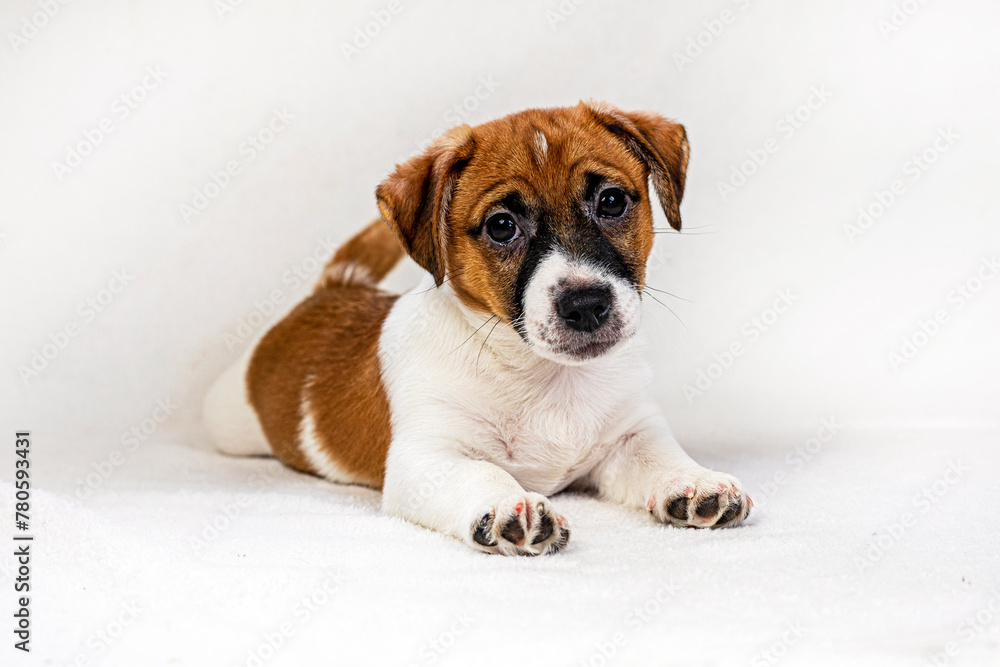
[{"x1": 646, "y1": 468, "x2": 753, "y2": 528}]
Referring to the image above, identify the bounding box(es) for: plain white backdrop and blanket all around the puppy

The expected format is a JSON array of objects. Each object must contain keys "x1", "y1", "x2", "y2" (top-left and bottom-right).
[{"x1": 0, "y1": 0, "x2": 1000, "y2": 667}]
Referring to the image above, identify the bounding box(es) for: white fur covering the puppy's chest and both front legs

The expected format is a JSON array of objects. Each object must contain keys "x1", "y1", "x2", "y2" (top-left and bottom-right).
[{"x1": 379, "y1": 270, "x2": 737, "y2": 553}]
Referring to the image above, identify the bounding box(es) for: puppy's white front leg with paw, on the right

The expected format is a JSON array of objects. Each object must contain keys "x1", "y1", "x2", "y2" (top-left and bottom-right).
[{"x1": 586, "y1": 416, "x2": 753, "y2": 528}]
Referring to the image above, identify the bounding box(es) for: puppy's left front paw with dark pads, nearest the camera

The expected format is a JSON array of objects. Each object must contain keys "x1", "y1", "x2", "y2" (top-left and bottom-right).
[{"x1": 469, "y1": 493, "x2": 569, "y2": 556}]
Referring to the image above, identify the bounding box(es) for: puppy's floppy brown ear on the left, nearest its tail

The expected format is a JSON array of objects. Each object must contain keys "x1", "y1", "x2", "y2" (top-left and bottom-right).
[{"x1": 375, "y1": 125, "x2": 475, "y2": 285}]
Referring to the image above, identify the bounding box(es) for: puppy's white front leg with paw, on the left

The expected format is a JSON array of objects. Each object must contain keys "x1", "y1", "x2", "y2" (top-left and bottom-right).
[{"x1": 382, "y1": 448, "x2": 569, "y2": 556}]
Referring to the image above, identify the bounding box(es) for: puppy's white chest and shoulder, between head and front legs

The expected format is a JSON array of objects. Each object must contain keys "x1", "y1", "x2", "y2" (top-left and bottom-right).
[{"x1": 380, "y1": 290, "x2": 648, "y2": 494}]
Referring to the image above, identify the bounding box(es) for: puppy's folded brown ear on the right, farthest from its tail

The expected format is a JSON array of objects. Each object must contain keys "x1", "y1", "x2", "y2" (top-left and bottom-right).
[{"x1": 580, "y1": 102, "x2": 689, "y2": 231}]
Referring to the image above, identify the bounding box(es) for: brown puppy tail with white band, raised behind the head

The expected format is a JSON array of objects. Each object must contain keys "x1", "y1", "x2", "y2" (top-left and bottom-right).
[{"x1": 316, "y1": 218, "x2": 403, "y2": 291}]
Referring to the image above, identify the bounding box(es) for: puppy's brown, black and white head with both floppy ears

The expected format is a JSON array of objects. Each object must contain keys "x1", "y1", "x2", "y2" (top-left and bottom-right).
[{"x1": 376, "y1": 102, "x2": 688, "y2": 364}]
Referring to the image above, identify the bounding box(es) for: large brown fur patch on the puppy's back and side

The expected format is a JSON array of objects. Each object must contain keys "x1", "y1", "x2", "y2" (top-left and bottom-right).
[{"x1": 247, "y1": 287, "x2": 398, "y2": 488}]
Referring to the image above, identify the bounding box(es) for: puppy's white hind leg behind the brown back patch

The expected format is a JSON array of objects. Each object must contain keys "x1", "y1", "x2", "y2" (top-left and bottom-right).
[{"x1": 203, "y1": 348, "x2": 271, "y2": 456}]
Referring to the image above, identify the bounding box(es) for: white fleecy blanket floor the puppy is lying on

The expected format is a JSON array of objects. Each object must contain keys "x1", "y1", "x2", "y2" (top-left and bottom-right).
[{"x1": 0, "y1": 431, "x2": 1000, "y2": 667}]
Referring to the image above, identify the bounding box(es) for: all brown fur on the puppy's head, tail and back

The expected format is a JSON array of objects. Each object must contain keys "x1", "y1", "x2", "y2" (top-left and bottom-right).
[{"x1": 247, "y1": 103, "x2": 687, "y2": 488}]
